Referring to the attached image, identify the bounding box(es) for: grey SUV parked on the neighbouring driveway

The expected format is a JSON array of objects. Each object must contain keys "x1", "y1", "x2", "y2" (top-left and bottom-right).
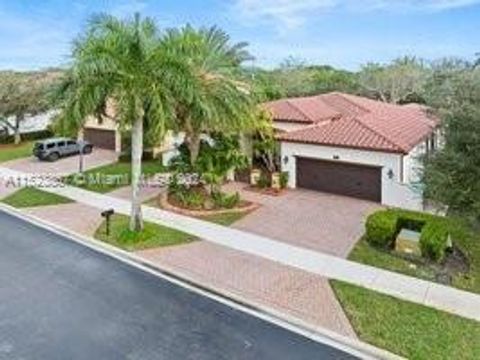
[{"x1": 33, "y1": 138, "x2": 93, "y2": 161}]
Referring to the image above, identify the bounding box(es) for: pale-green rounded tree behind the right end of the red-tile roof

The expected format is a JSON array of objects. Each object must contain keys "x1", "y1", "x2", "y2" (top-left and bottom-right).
[{"x1": 359, "y1": 57, "x2": 429, "y2": 104}]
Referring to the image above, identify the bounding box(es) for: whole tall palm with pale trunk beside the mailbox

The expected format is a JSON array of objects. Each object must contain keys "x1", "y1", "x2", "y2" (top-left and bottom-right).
[{"x1": 56, "y1": 14, "x2": 176, "y2": 231}]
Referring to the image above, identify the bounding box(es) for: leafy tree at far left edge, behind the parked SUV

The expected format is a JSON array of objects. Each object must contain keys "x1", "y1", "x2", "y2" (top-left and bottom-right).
[{"x1": 0, "y1": 70, "x2": 61, "y2": 144}]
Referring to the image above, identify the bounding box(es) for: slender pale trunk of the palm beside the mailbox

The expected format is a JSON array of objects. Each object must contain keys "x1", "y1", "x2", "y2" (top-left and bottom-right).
[{"x1": 130, "y1": 115, "x2": 143, "y2": 231}]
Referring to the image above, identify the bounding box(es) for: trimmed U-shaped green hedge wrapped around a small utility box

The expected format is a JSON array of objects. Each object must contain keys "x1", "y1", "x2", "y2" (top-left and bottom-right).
[{"x1": 365, "y1": 209, "x2": 449, "y2": 262}]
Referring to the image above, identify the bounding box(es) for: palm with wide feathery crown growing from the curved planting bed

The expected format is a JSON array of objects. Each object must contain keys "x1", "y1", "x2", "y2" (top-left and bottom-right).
[{"x1": 162, "y1": 25, "x2": 255, "y2": 165}]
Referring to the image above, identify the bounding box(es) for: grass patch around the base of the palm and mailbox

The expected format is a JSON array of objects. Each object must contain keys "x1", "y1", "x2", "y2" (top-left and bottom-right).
[{"x1": 95, "y1": 215, "x2": 195, "y2": 251}]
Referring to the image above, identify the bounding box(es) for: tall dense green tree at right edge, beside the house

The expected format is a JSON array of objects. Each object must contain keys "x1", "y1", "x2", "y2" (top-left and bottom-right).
[{"x1": 423, "y1": 62, "x2": 480, "y2": 221}]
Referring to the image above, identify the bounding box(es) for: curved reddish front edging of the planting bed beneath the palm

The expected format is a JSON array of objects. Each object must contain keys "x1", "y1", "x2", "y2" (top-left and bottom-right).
[{"x1": 157, "y1": 193, "x2": 259, "y2": 217}]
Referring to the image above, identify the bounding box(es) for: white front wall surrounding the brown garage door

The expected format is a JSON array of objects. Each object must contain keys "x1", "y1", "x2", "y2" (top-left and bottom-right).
[{"x1": 281, "y1": 142, "x2": 423, "y2": 210}]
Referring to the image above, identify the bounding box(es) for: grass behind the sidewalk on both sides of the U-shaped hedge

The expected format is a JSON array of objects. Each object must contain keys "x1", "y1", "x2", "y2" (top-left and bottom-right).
[{"x1": 348, "y1": 218, "x2": 480, "y2": 293}]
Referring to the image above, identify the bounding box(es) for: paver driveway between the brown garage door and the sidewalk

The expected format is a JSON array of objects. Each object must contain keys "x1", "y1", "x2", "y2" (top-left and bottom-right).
[{"x1": 225, "y1": 183, "x2": 381, "y2": 257}]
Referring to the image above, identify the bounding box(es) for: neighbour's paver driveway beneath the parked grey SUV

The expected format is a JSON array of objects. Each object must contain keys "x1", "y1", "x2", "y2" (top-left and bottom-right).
[{"x1": 2, "y1": 149, "x2": 118, "y2": 176}]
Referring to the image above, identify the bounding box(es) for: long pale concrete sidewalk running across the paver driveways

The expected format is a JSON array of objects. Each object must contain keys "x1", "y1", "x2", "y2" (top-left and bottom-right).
[{"x1": 0, "y1": 167, "x2": 480, "y2": 321}]
